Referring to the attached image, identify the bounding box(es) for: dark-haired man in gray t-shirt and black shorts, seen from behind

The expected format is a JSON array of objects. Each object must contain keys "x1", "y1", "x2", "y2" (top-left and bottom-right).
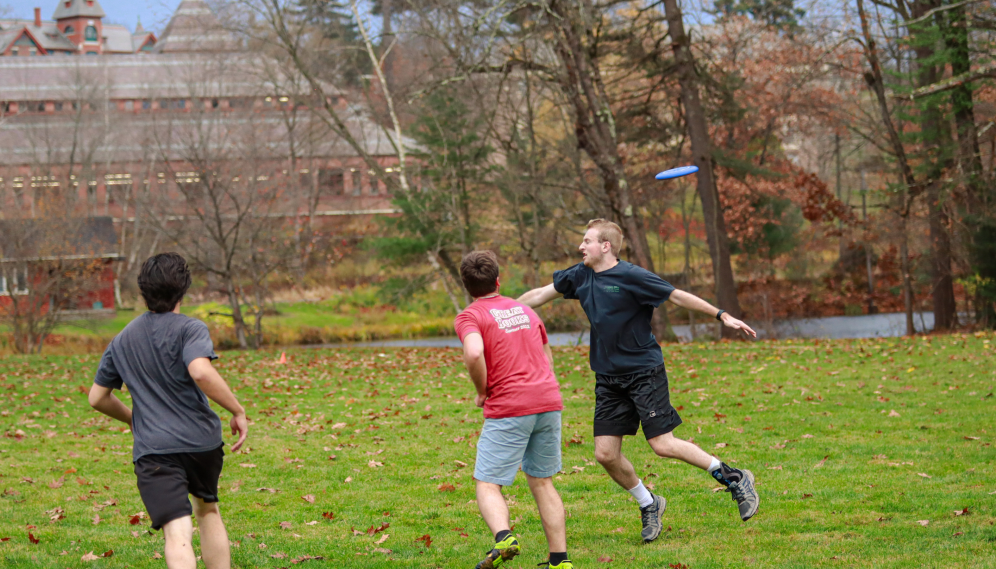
[{"x1": 89, "y1": 253, "x2": 249, "y2": 569}]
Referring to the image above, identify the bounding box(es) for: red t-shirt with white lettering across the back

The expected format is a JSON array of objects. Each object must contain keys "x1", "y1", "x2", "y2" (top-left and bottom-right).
[{"x1": 453, "y1": 296, "x2": 564, "y2": 419}]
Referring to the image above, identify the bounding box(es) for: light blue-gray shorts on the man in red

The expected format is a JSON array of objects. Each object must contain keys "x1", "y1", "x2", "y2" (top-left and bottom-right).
[{"x1": 474, "y1": 411, "x2": 561, "y2": 486}]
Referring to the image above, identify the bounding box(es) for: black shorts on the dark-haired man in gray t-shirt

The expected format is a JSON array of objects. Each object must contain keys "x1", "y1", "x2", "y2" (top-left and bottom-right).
[{"x1": 135, "y1": 445, "x2": 225, "y2": 529}]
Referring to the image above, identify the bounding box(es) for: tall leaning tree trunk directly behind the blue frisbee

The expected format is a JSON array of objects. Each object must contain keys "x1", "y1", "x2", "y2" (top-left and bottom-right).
[{"x1": 664, "y1": 0, "x2": 743, "y2": 338}]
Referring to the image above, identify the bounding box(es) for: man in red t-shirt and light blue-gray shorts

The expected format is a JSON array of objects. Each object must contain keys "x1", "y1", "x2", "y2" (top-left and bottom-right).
[{"x1": 454, "y1": 251, "x2": 574, "y2": 569}]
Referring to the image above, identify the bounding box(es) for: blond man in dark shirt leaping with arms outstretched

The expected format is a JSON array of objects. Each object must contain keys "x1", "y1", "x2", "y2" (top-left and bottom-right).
[{"x1": 518, "y1": 219, "x2": 759, "y2": 542}]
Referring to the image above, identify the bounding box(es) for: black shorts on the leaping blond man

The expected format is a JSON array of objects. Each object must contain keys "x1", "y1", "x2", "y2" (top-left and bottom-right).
[{"x1": 595, "y1": 364, "x2": 681, "y2": 439}]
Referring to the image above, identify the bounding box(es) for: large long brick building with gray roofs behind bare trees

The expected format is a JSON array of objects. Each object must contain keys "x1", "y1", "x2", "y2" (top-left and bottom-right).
[{"x1": 0, "y1": 0, "x2": 404, "y2": 223}]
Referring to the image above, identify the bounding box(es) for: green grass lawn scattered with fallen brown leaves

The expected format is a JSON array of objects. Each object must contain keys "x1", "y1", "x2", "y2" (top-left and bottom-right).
[{"x1": 0, "y1": 335, "x2": 996, "y2": 569}]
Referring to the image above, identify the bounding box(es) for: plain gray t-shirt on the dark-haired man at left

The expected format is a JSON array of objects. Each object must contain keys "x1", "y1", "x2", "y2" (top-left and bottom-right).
[{"x1": 94, "y1": 312, "x2": 224, "y2": 460}]
